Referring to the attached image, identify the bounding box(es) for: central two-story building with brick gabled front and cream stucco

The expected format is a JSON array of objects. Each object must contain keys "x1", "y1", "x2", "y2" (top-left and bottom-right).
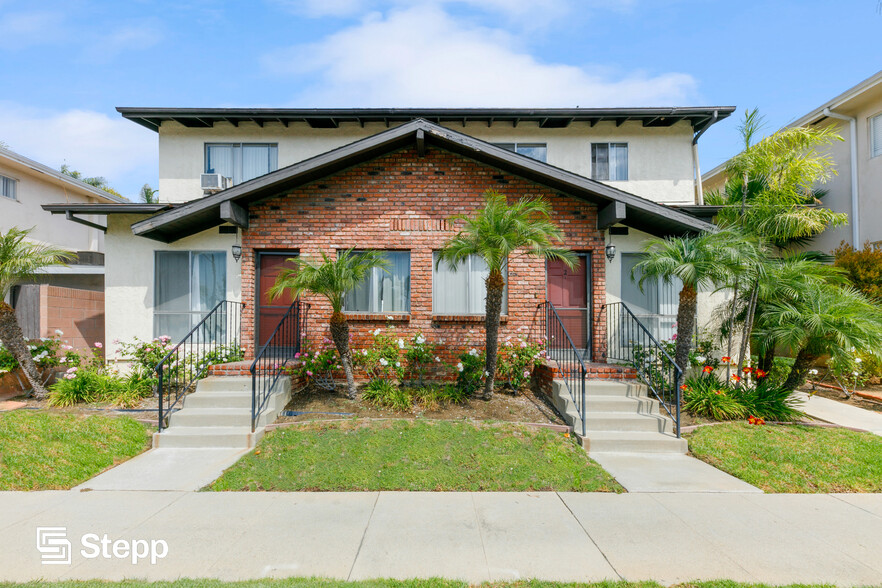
[{"x1": 43, "y1": 107, "x2": 734, "y2": 361}]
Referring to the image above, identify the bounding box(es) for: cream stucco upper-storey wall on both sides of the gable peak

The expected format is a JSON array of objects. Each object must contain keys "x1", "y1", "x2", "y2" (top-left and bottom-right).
[{"x1": 159, "y1": 121, "x2": 694, "y2": 204}]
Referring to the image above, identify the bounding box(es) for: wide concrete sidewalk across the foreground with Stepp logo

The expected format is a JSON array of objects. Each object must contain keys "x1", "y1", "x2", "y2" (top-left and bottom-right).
[{"x1": 0, "y1": 491, "x2": 882, "y2": 586}]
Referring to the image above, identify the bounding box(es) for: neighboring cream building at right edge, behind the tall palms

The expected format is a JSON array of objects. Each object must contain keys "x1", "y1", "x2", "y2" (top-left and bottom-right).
[{"x1": 702, "y1": 71, "x2": 882, "y2": 252}]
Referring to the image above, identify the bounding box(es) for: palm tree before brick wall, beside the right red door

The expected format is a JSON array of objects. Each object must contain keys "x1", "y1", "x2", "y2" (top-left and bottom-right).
[{"x1": 437, "y1": 190, "x2": 578, "y2": 400}]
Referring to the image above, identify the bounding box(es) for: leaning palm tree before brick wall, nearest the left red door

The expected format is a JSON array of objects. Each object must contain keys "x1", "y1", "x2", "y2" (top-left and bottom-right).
[{"x1": 269, "y1": 249, "x2": 389, "y2": 399}]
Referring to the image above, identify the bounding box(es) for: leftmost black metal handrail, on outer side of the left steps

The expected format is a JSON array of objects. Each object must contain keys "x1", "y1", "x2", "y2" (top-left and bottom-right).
[{"x1": 154, "y1": 300, "x2": 244, "y2": 431}]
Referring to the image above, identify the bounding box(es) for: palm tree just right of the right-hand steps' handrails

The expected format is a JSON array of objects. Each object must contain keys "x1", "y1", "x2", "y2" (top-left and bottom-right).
[{"x1": 631, "y1": 231, "x2": 758, "y2": 372}]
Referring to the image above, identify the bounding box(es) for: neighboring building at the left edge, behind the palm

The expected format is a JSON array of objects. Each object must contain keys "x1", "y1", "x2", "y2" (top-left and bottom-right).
[{"x1": 0, "y1": 148, "x2": 127, "y2": 347}]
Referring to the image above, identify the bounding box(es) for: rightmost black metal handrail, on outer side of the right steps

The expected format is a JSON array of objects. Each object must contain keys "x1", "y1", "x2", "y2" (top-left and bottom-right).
[{"x1": 604, "y1": 302, "x2": 683, "y2": 437}]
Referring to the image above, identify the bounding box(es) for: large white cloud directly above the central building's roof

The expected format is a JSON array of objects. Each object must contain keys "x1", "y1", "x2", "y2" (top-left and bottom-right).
[{"x1": 262, "y1": 6, "x2": 695, "y2": 107}]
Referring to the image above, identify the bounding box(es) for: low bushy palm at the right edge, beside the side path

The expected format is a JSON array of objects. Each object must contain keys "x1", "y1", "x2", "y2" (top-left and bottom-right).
[{"x1": 763, "y1": 284, "x2": 882, "y2": 390}]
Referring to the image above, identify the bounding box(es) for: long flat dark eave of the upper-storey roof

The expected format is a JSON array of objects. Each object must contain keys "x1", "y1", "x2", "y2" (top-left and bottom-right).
[{"x1": 116, "y1": 106, "x2": 735, "y2": 132}]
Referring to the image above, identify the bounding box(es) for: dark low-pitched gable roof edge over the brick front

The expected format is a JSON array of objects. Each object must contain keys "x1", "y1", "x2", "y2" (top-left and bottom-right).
[{"x1": 132, "y1": 119, "x2": 713, "y2": 242}]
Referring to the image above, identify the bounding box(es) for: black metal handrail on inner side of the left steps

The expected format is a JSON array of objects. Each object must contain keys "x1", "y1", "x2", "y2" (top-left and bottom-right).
[{"x1": 249, "y1": 300, "x2": 309, "y2": 432}]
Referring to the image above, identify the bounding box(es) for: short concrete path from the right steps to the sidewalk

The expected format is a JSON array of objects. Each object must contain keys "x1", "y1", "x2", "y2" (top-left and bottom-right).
[{"x1": 589, "y1": 451, "x2": 762, "y2": 493}]
